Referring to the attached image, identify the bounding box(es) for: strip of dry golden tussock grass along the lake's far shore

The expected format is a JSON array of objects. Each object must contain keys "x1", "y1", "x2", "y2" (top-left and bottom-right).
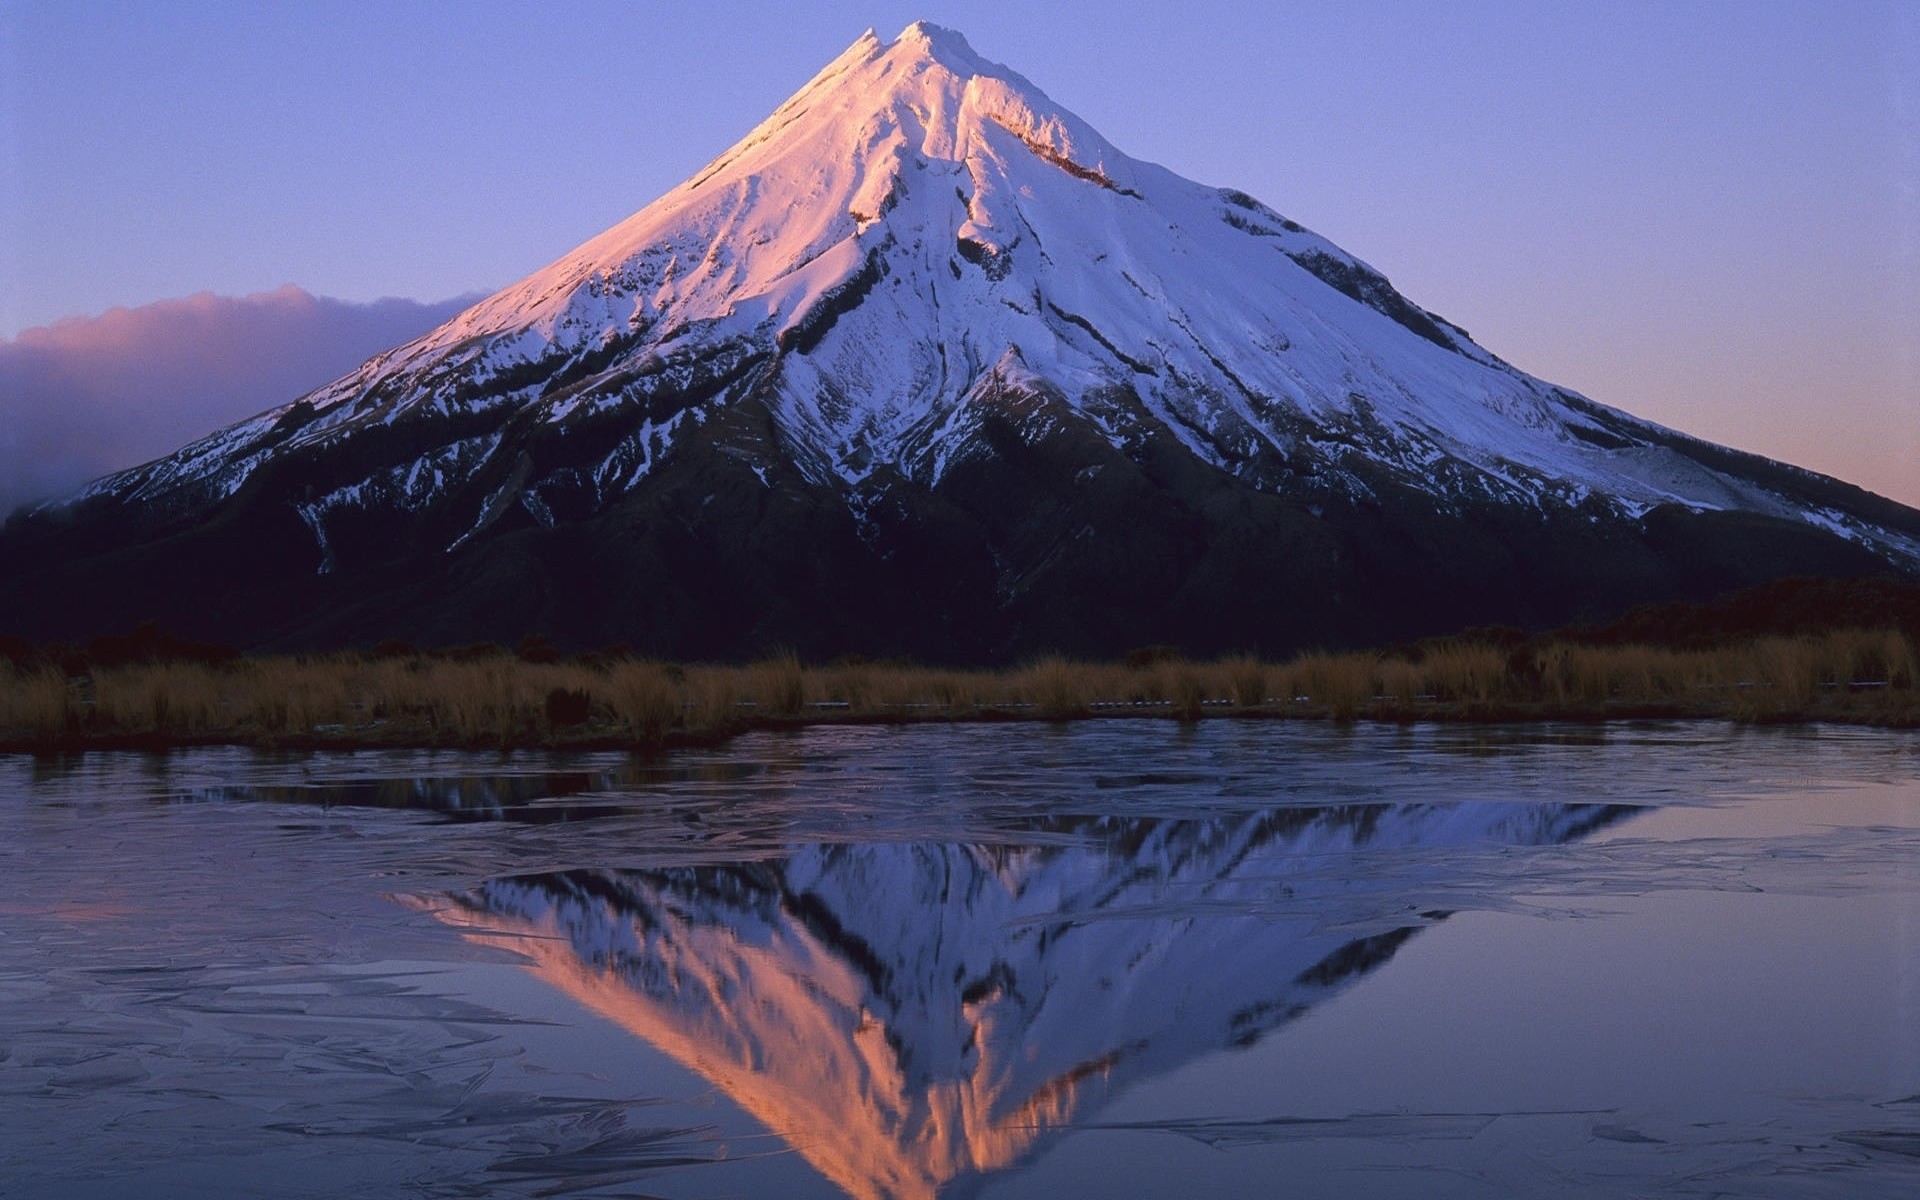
[{"x1": 0, "y1": 630, "x2": 1920, "y2": 745}]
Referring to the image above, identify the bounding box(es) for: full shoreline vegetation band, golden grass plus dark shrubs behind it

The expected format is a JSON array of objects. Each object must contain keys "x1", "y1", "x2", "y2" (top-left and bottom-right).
[{"x1": 0, "y1": 580, "x2": 1920, "y2": 749}]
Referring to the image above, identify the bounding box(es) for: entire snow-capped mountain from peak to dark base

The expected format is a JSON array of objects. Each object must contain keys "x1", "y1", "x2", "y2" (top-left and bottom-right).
[{"x1": 0, "y1": 23, "x2": 1920, "y2": 660}]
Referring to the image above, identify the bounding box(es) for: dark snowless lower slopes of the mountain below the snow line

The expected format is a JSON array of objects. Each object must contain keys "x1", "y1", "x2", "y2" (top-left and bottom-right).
[{"x1": 0, "y1": 364, "x2": 1887, "y2": 660}]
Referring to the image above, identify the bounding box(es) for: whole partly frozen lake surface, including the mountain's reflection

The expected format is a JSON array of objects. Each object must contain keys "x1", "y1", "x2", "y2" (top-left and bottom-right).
[{"x1": 0, "y1": 722, "x2": 1920, "y2": 1198}]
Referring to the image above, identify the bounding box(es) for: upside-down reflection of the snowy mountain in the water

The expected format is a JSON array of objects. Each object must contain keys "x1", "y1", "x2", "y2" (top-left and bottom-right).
[{"x1": 428, "y1": 803, "x2": 1630, "y2": 1198}]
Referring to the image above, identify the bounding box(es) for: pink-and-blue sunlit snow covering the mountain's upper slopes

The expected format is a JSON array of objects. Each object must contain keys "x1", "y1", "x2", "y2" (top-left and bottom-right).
[{"x1": 60, "y1": 23, "x2": 1920, "y2": 572}]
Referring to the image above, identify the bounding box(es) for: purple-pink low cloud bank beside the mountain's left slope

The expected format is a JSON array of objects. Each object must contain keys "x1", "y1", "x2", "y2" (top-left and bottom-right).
[{"x1": 0, "y1": 284, "x2": 474, "y2": 516}]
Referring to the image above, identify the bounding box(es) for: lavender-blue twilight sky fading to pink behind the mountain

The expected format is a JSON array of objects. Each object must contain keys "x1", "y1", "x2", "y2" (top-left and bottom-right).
[{"x1": 0, "y1": 0, "x2": 1920, "y2": 505}]
